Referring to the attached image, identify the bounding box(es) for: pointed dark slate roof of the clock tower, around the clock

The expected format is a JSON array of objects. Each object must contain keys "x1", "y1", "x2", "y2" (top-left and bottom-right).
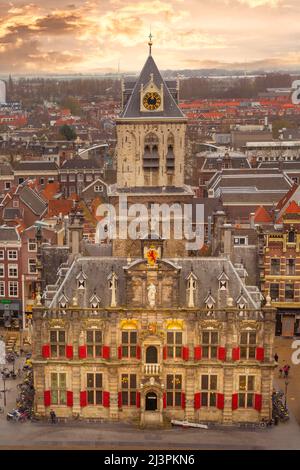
[{"x1": 119, "y1": 55, "x2": 186, "y2": 119}]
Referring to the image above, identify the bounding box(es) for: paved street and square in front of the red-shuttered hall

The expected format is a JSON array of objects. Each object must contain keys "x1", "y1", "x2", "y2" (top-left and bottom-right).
[{"x1": 0, "y1": 346, "x2": 300, "y2": 450}]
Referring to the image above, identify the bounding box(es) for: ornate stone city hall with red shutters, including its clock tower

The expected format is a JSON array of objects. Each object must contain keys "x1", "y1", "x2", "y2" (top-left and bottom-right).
[{"x1": 33, "y1": 42, "x2": 275, "y2": 426}]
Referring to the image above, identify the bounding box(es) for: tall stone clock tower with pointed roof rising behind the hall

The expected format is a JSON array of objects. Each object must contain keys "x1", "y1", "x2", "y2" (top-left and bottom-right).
[{"x1": 109, "y1": 36, "x2": 193, "y2": 257}]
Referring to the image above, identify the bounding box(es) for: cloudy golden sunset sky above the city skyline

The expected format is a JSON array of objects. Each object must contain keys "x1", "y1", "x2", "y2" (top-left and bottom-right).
[{"x1": 0, "y1": 0, "x2": 300, "y2": 74}]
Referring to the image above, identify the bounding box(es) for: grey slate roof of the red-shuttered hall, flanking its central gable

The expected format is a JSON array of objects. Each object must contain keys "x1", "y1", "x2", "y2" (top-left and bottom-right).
[{"x1": 47, "y1": 257, "x2": 258, "y2": 308}]
